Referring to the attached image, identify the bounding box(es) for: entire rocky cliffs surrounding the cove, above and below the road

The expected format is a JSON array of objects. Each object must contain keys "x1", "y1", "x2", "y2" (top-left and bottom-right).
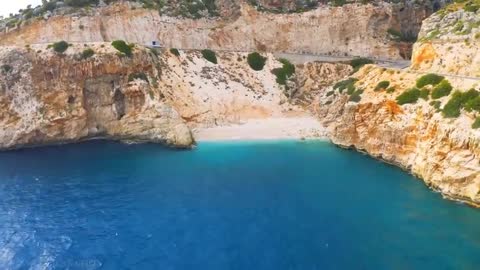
[{"x1": 0, "y1": 0, "x2": 480, "y2": 205}]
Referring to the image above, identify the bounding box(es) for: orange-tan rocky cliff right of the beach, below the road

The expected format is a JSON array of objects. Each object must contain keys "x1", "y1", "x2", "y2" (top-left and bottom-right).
[{"x1": 315, "y1": 66, "x2": 480, "y2": 205}]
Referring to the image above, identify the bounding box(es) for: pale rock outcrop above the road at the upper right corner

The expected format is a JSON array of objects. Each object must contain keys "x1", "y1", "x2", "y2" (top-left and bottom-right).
[{"x1": 412, "y1": 4, "x2": 480, "y2": 77}]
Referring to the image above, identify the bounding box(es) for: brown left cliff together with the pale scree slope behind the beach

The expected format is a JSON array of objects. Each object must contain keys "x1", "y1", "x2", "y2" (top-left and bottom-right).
[{"x1": 0, "y1": 43, "x2": 342, "y2": 149}]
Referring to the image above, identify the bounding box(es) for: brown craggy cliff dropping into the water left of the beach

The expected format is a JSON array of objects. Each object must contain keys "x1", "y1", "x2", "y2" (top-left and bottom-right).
[{"x1": 0, "y1": 47, "x2": 193, "y2": 148}]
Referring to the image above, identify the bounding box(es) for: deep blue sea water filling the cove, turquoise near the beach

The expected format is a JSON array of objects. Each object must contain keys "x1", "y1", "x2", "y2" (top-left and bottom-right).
[{"x1": 0, "y1": 141, "x2": 480, "y2": 270}]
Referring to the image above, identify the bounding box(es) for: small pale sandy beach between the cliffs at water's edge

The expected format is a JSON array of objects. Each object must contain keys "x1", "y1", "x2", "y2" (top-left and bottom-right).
[{"x1": 193, "y1": 117, "x2": 326, "y2": 141}]
